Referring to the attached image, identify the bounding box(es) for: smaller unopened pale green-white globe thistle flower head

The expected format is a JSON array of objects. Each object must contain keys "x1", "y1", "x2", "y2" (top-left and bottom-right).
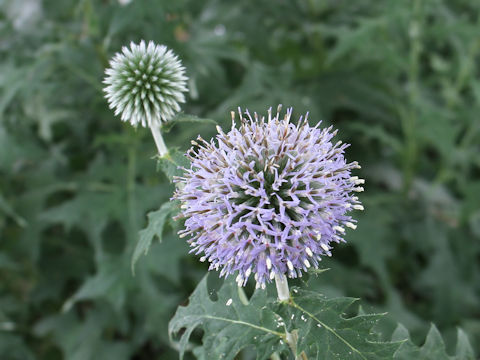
[{"x1": 104, "y1": 40, "x2": 187, "y2": 127}]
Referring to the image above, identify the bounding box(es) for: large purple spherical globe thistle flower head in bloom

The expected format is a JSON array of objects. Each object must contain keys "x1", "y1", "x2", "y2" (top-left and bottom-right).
[{"x1": 174, "y1": 106, "x2": 364, "y2": 287}]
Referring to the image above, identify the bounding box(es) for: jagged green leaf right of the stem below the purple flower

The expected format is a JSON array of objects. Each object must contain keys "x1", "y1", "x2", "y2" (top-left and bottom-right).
[{"x1": 279, "y1": 288, "x2": 401, "y2": 360}]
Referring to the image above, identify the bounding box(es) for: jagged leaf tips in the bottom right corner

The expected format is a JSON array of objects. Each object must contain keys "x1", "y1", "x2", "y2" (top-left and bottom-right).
[{"x1": 392, "y1": 324, "x2": 475, "y2": 360}]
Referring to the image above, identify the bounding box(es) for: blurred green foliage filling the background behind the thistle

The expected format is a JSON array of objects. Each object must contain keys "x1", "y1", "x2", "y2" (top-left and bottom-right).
[{"x1": 0, "y1": 0, "x2": 480, "y2": 360}]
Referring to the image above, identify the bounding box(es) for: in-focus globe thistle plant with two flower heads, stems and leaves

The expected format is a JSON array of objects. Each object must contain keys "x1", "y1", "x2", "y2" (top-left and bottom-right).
[{"x1": 100, "y1": 41, "x2": 470, "y2": 360}]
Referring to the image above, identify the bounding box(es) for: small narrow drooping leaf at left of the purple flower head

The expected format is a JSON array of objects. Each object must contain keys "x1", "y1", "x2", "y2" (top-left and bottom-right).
[{"x1": 132, "y1": 201, "x2": 178, "y2": 272}]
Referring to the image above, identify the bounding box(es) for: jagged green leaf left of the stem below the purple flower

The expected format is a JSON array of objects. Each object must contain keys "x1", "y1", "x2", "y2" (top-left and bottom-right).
[{"x1": 168, "y1": 275, "x2": 287, "y2": 360}]
